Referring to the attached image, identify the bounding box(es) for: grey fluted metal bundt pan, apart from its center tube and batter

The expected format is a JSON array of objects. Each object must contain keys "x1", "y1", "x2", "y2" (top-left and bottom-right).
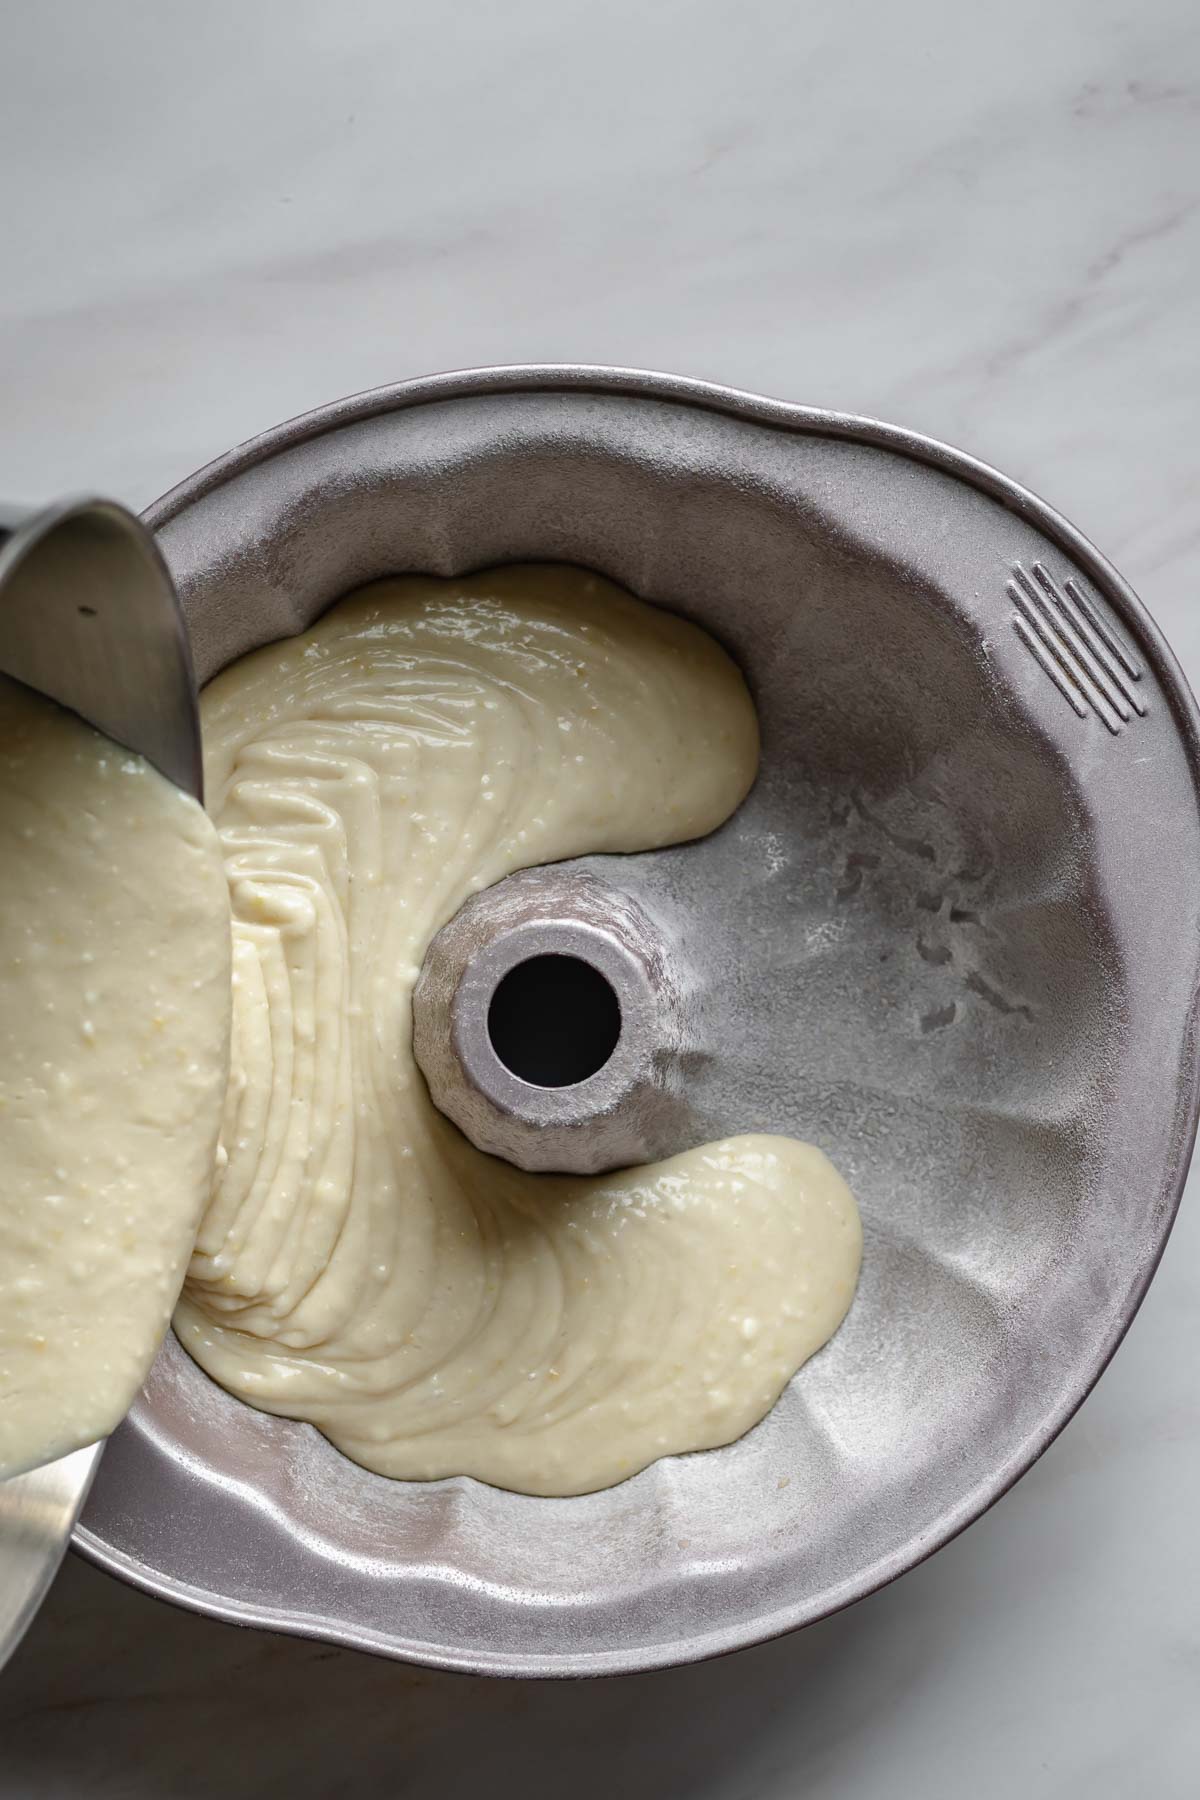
[{"x1": 76, "y1": 367, "x2": 1200, "y2": 1674}]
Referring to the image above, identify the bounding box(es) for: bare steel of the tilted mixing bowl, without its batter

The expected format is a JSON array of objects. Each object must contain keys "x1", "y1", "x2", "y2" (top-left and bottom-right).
[{"x1": 0, "y1": 499, "x2": 203, "y2": 1669}]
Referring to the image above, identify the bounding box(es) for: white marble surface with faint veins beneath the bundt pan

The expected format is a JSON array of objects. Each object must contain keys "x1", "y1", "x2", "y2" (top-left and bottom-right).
[{"x1": 0, "y1": 0, "x2": 1200, "y2": 1800}]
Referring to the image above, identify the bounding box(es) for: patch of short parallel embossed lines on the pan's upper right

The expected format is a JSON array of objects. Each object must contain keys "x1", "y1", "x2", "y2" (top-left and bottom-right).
[{"x1": 1007, "y1": 562, "x2": 1146, "y2": 738}]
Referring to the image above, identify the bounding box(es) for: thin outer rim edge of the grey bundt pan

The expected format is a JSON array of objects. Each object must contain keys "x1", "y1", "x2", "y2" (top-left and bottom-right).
[{"x1": 72, "y1": 364, "x2": 1200, "y2": 1678}]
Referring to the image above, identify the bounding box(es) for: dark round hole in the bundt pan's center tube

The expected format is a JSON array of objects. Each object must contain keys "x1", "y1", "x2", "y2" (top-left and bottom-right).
[{"x1": 488, "y1": 956, "x2": 621, "y2": 1087}]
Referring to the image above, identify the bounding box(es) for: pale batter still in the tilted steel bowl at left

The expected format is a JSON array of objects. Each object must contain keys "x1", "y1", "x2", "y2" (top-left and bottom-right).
[{"x1": 0, "y1": 677, "x2": 230, "y2": 1476}]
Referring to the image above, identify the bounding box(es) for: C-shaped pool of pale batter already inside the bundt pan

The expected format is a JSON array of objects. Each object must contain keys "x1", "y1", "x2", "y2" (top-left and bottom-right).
[{"x1": 176, "y1": 565, "x2": 860, "y2": 1494}]
